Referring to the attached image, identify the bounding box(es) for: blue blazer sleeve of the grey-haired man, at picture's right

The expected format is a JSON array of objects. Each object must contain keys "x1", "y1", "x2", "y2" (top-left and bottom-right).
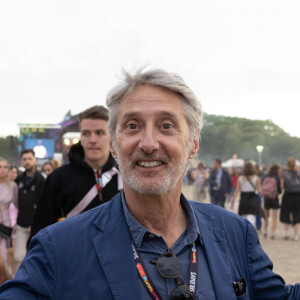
[{"x1": 247, "y1": 219, "x2": 300, "y2": 300}]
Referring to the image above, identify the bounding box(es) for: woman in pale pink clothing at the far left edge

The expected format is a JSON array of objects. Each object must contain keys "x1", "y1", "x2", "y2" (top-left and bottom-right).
[{"x1": 0, "y1": 157, "x2": 18, "y2": 279}]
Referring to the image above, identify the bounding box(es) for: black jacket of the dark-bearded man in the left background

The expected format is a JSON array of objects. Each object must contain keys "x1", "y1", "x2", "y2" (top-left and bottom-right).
[{"x1": 16, "y1": 171, "x2": 45, "y2": 227}]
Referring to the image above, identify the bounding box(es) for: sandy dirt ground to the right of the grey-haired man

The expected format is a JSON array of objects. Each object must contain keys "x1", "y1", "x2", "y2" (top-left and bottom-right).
[{"x1": 183, "y1": 185, "x2": 300, "y2": 284}]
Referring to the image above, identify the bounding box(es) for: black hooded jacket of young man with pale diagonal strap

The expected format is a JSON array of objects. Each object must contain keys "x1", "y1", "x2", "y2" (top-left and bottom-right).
[{"x1": 31, "y1": 143, "x2": 120, "y2": 237}]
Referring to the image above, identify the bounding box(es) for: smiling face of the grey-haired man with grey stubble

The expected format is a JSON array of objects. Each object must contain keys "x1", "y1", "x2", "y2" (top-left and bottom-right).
[{"x1": 112, "y1": 85, "x2": 198, "y2": 195}]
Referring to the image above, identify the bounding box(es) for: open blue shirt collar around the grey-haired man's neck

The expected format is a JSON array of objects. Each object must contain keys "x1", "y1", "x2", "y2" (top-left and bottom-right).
[{"x1": 121, "y1": 191, "x2": 203, "y2": 247}]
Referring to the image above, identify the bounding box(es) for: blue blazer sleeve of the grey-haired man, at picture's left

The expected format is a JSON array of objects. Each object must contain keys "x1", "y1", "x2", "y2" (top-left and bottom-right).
[{"x1": 0, "y1": 230, "x2": 56, "y2": 300}]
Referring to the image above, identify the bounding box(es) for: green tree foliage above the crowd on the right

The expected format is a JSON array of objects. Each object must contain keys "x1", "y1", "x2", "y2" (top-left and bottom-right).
[{"x1": 198, "y1": 114, "x2": 300, "y2": 165}]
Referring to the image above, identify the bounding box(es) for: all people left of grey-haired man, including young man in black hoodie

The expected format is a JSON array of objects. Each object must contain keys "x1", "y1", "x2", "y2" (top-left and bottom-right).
[{"x1": 0, "y1": 106, "x2": 122, "y2": 282}]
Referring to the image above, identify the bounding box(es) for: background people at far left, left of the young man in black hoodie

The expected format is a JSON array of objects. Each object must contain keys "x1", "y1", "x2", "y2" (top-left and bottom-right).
[{"x1": 0, "y1": 154, "x2": 57, "y2": 282}]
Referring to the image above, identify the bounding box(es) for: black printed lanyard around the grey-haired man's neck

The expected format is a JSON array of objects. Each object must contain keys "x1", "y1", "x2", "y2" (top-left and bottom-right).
[{"x1": 130, "y1": 236, "x2": 198, "y2": 300}]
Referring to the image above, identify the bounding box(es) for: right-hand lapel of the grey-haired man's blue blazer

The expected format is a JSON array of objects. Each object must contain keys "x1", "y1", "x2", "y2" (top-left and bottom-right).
[{"x1": 198, "y1": 212, "x2": 236, "y2": 300}]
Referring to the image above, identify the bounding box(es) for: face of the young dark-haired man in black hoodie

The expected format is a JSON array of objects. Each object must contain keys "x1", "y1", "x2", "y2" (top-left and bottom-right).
[{"x1": 80, "y1": 119, "x2": 109, "y2": 167}]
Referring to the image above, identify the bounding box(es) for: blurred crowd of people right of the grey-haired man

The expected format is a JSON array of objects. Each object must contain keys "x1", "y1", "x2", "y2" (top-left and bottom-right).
[{"x1": 188, "y1": 158, "x2": 300, "y2": 241}]
